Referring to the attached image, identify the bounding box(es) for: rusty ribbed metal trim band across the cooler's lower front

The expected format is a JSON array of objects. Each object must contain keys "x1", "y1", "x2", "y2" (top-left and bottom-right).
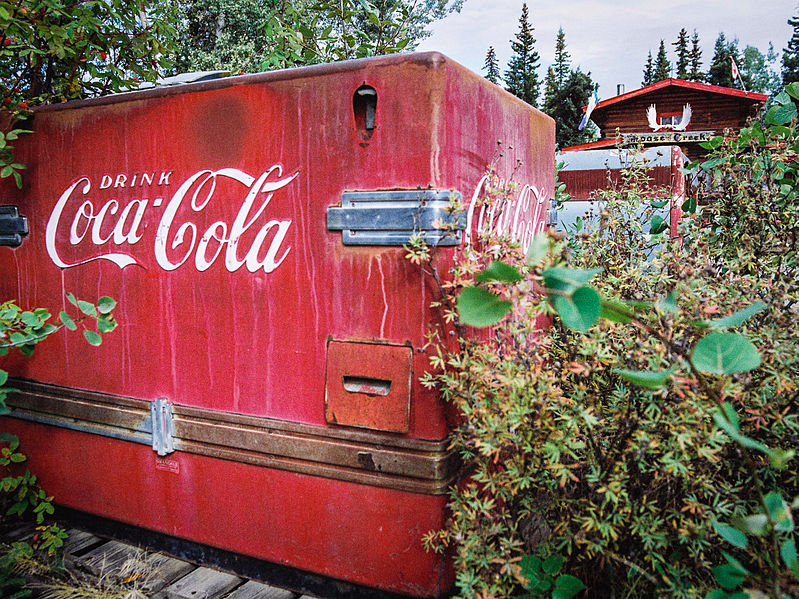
[{"x1": 8, "y1": 382, "x2": 456, "y2": 494}]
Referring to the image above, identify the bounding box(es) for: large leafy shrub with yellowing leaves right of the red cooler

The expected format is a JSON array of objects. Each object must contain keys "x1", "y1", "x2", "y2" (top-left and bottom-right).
[{"x1": 411, "y1": 86, "x2": 799, "y2": 599}]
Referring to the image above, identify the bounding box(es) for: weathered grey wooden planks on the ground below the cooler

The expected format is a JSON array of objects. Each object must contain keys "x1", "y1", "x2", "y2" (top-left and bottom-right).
[{"x1": 0, "y1": 525, "x2": 322, "y2": 599}]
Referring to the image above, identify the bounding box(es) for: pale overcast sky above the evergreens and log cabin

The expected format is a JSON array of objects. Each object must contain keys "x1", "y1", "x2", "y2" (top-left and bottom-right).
[{"x1": 419, "y1": 0, "x2": 797, "y2": 99}]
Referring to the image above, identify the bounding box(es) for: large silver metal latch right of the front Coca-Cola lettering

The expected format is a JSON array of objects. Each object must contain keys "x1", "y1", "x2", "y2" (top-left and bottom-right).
[{"x1": 327, "y1": 189, "x2": 466, "y2": 245}]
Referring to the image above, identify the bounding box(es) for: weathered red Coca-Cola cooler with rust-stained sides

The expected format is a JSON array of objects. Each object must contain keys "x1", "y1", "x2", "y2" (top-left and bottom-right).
[{"x1": 0, "y1": 53, "x2": 554, "y2": 596}]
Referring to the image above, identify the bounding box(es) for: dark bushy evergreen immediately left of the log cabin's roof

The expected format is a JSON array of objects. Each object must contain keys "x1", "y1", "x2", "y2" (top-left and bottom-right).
[{"x1": 542, "y1": 68, "x2": 597, "y2": 148}]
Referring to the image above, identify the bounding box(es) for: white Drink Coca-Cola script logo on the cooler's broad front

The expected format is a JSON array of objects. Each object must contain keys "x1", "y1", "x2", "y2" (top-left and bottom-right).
[{"x1": 45, "y1": 165, "x2": 299, "y2": 273}]
